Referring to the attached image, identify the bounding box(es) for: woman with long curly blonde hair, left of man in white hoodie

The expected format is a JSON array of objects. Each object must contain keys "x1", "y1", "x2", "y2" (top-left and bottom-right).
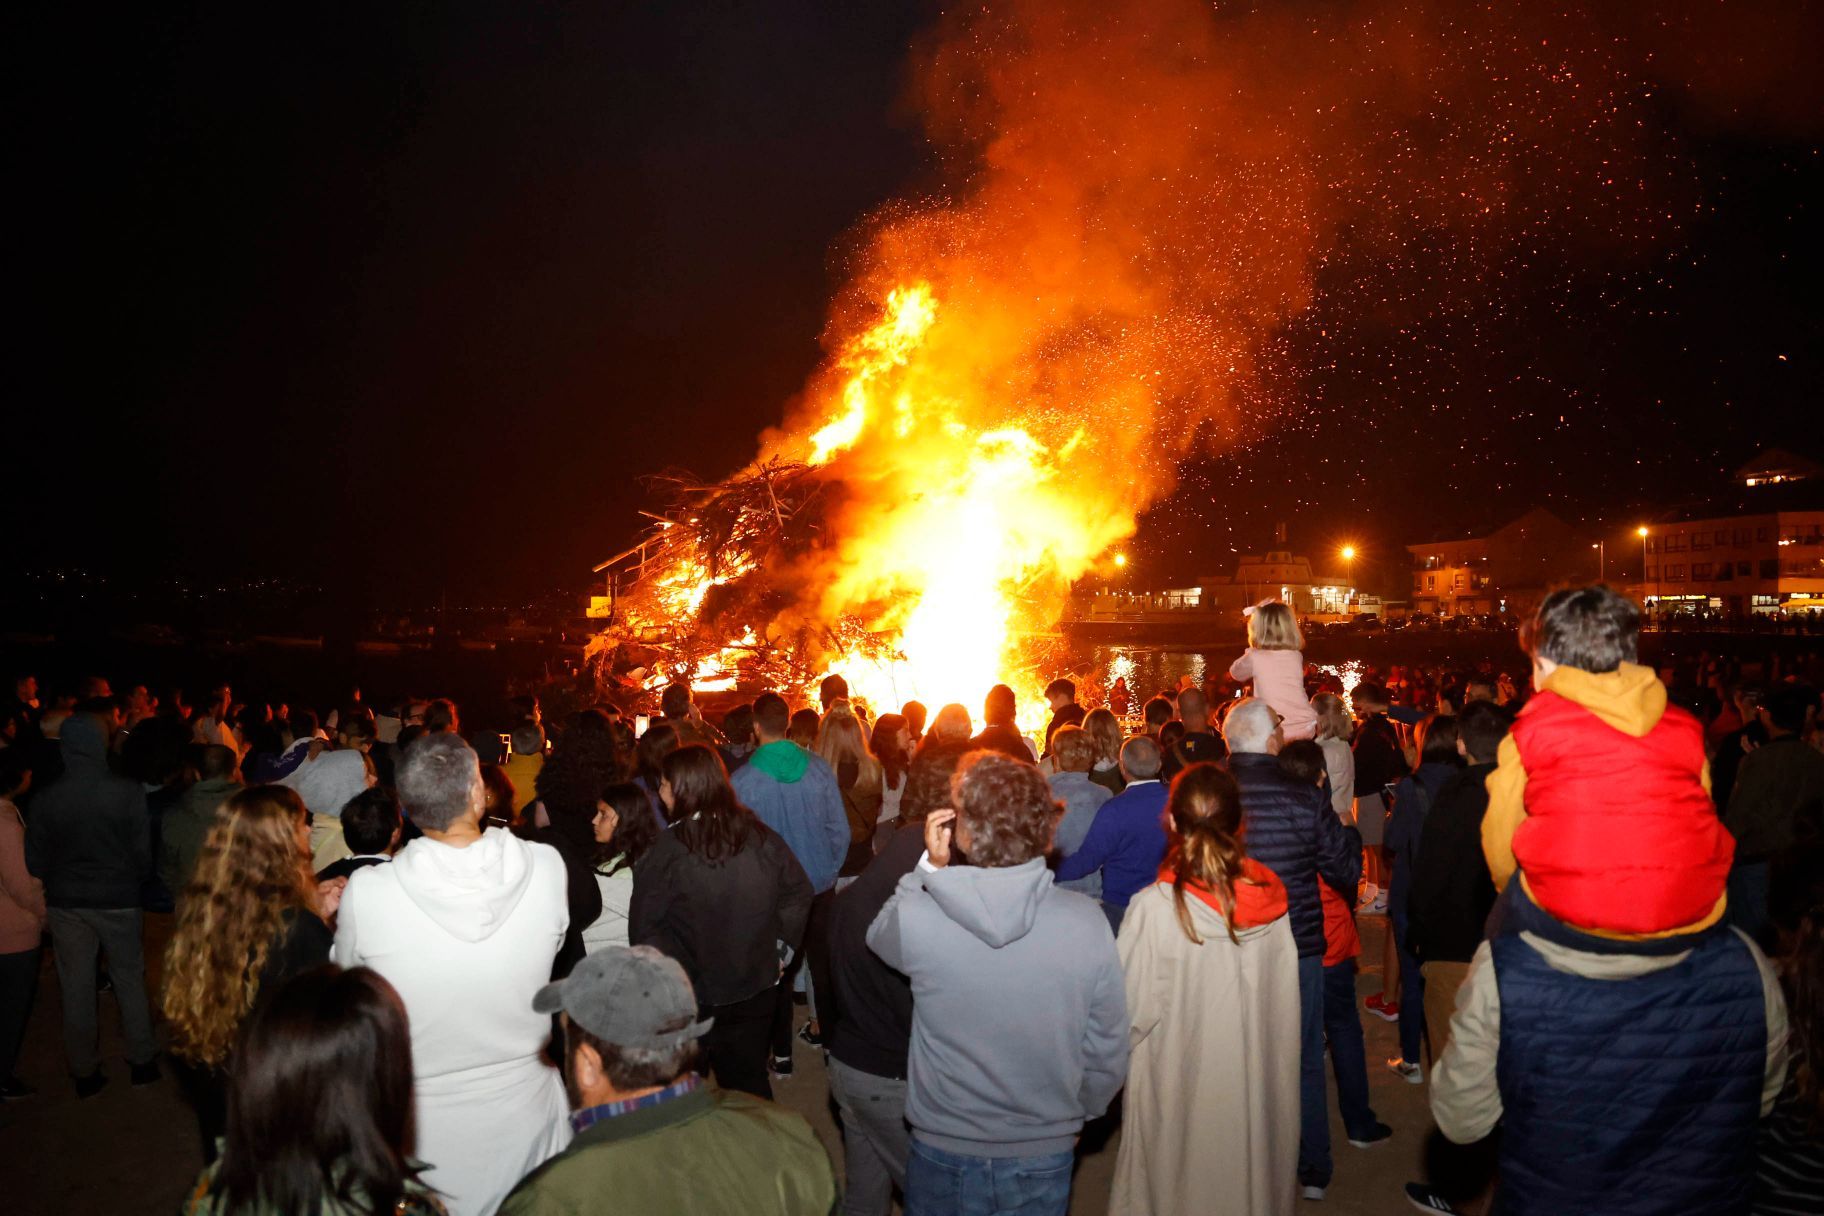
[{"x1": 162, "y1": 786, "x2": 348, "y2": 1159}]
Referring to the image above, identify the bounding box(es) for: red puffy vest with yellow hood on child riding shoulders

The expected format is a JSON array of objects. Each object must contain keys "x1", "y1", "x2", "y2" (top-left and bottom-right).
[{"x1": 1485, "y1": 664, "x2": 1735, "y2": 935}]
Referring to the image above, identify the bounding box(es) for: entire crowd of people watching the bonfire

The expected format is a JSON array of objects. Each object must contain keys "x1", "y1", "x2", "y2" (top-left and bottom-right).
[{"x1": 0, "y1": 587, "x2": 1824, "y2": 1216}]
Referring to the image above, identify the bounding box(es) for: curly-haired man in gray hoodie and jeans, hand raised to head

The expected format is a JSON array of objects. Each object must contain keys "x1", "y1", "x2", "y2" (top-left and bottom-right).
[{"x1": 868, "y1": 753, "x2": 1127, "y2": 1216}]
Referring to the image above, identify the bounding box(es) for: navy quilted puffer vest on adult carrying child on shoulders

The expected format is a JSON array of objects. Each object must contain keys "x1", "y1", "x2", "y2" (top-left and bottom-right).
[{"x1": 1490, "y1": 882, "x2": 1767, "y2": 1216}]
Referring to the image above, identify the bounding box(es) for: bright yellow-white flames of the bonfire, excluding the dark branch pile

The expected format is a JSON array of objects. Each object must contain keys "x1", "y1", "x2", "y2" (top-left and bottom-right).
[{"x1": 758, "y1": 283, "x2": 1133, "y2": 726}]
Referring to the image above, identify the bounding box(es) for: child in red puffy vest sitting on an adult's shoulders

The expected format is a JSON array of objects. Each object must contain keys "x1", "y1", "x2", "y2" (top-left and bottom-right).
[{"x1": 1483, "y1": 587, "x2": 1735, "y2": 937}]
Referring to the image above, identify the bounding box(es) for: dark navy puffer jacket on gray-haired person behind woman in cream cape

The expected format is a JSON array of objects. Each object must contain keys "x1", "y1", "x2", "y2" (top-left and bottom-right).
[{"x1": 1229, "y1": 751, "x2": 1363, "y2": 959}]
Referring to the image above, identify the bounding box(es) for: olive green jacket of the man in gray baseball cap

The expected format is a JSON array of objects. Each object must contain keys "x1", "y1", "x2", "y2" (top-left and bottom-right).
[{"x1": 500, "y1": 1085, "x2": 837, "y2": 1216}]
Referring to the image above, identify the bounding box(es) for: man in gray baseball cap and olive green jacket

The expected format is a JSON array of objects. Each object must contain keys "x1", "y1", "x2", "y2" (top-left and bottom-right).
[{"x1": 500, "y1": 946, "x2": 837, "y2": 1216}]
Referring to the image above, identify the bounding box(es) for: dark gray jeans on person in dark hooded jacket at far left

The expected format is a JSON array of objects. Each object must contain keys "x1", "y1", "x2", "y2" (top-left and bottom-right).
[{"x1": 49, "y1": 908, "x2": 159, "y2": 1077}]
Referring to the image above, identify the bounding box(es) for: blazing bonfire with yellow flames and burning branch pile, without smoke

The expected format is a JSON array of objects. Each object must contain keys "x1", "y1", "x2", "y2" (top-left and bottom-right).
[{"x1": 595, "y1": 283, "x2": 1133, "y2": 721}]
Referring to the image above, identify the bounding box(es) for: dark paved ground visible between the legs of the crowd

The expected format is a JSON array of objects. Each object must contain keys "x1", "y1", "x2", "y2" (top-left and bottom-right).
[{"x1": 10, "y1": 917, "x2": 1430, "y2": 1216}]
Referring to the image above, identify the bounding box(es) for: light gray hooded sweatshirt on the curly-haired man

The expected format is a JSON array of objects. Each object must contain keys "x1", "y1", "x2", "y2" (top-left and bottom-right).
[{"x1": 868, "y1": 859, "x2": 1127, "y2": 1158}]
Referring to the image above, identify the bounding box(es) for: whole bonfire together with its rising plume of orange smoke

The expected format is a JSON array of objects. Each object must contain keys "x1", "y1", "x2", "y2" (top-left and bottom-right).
[{"x1": 595, "y1": 0, "x2": 1736, "y2": 709}]
